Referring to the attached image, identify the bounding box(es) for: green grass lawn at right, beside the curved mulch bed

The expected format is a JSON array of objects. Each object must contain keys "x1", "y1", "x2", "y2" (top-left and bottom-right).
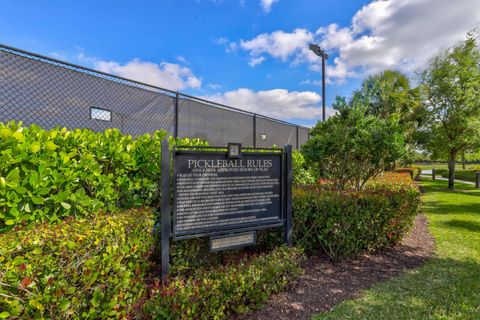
[{"x1": 314, "y1": 180, "x2": 480, "y2": 320}]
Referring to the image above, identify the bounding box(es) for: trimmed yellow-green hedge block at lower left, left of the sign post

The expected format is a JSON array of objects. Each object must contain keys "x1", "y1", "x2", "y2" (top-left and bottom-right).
[{"x1": 0, "y1": 210, "x2": 153, "y2": 319}]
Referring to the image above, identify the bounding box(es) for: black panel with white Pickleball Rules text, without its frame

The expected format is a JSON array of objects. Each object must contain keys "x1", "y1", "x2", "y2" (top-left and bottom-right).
[{"x1": 174, "y1": 153, "x2": 282, "y2": 235}]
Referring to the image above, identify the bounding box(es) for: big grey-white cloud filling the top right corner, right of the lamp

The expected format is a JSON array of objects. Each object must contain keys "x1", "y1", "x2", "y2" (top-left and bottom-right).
[{"x1": 319, "y1": 0, "x2": 480, "y2": 79}]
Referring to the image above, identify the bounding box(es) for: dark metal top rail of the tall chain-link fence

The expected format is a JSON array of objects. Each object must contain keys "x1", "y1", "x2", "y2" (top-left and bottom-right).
[{"x1": 0, "y1": 43, "x2": 310, "y2": 130}]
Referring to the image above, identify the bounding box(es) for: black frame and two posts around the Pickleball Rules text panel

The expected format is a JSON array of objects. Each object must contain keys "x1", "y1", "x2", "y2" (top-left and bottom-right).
[{"x1": 160, "y1": 139, "x2": 293, "y2": 284}]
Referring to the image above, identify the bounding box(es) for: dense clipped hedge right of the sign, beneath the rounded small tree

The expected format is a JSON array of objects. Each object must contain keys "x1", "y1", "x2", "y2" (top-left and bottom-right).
[{"x1": 293, "y1": 173, "x2": 420, "y2": 260}]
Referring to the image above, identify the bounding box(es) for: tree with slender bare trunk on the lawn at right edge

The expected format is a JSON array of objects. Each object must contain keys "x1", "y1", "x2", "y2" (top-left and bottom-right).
[{"x1": 420, "y1": 32, "x2": 480, "y2": 189}]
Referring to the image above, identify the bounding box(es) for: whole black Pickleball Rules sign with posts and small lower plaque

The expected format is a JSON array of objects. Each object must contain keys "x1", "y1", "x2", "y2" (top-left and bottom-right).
[{"x1": 162, "y1": 142, "x2": 292, "y2": 284}]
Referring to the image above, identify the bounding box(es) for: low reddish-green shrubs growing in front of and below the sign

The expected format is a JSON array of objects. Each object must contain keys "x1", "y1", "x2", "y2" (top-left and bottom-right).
[{"x1": 144, "y1": 247, "x2": 302, "y2": 319}]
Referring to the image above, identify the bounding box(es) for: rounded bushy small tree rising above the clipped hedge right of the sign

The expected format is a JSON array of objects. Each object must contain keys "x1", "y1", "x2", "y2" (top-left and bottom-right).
[{"x1": 302, "y1": 104, "x2": 405, "y2": 190}]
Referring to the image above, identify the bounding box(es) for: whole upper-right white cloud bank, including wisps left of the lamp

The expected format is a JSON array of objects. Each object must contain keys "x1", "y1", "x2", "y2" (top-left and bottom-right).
[{"x1": 233, "y1": 0, "x2": 480, "y2": 81}]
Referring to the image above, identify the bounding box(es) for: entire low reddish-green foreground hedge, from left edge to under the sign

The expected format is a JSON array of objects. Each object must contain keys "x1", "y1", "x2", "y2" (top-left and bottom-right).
[{"x1": 0, "y1": 206, "x2": 302, "y2": 319}]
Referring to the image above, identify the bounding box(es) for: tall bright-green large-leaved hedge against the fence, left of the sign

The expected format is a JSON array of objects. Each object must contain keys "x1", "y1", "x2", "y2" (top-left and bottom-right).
[{"x1": 0, "y1": 122, "x2": 205, "y2": 232}]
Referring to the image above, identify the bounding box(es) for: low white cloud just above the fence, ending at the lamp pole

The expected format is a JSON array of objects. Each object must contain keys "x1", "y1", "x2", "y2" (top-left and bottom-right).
[{"x1": 205, "y1": 88, "x2": 322, "y2": 119}]
